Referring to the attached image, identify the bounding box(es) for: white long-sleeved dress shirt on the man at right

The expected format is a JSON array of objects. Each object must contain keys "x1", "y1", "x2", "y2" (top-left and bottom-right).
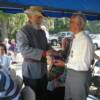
[{"x1": 67, "y1": 31, "x2": 94, "y2": 71}]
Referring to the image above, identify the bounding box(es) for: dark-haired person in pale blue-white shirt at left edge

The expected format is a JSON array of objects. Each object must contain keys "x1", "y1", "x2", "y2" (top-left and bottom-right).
[{"x1": 0, "y1": 43, "x2": 12, "y2": 71}]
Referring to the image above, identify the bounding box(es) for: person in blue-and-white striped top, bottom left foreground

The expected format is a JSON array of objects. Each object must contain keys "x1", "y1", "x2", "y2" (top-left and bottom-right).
[{"x1": 0, "y1": 65, "x2": 21, "y2": 100}]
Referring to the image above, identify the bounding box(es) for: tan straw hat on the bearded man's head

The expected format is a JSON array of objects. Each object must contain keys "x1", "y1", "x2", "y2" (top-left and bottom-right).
[{"x1": 24, "y1": 6, "x2": 43, "y2": 16}]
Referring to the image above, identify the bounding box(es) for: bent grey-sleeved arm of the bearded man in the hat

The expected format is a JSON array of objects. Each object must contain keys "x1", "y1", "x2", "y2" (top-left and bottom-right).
[{"x1": 17, "y1": 31, "x2": 43, "y2": 60}]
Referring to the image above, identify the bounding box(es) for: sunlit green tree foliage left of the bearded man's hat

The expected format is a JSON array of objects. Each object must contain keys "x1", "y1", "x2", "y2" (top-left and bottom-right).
[{"x1": 0, "y1": 13, "x2": 27, "y2": 39}]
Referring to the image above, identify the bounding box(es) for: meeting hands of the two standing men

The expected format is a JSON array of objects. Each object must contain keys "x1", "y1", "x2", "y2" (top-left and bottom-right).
[{"x1": 46, "y1": 50, "x2": 65, "y2": 67}]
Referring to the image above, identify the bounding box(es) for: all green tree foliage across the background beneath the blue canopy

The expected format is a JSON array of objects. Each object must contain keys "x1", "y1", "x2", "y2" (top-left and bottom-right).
[{"x1": 0, "y1": 12, "x2": 100, "y2": 39}]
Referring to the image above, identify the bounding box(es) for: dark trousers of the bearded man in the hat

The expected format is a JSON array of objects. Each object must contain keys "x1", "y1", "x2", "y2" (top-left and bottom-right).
[{"x1": 23, "y1": 75, "x2": 47, "y2": 100}]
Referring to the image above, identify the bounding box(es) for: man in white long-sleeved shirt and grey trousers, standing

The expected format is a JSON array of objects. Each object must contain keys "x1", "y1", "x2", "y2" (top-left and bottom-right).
[{"x1": 54, "y1": 14, "x2": 94, "y2": 100}]
